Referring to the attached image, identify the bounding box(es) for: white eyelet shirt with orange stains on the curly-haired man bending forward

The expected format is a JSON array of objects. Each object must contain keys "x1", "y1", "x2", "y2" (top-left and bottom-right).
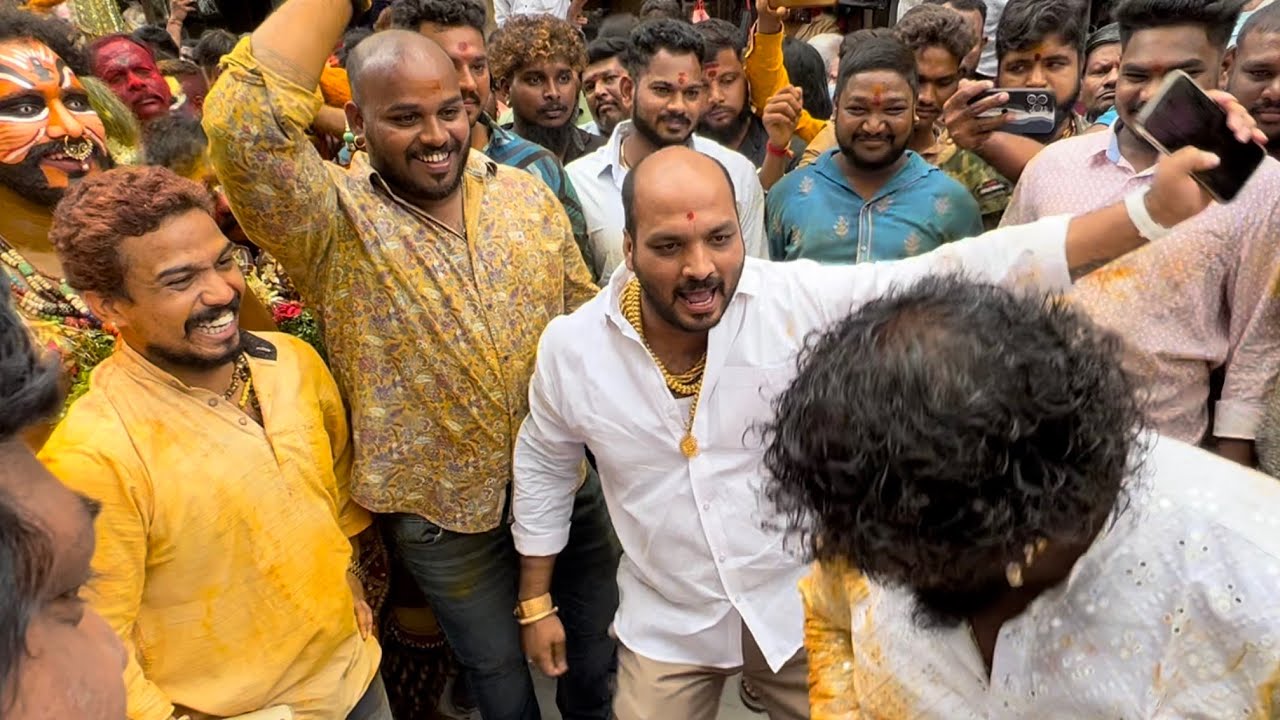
[{"x1": 805, "y1": 438, "x2": 1280, "y2": 720}]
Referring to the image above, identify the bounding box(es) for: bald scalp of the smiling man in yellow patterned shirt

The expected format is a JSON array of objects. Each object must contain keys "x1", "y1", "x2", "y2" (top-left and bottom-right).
[{"x1": 347, "y1": 29, "x2": 458, "y2": 105}]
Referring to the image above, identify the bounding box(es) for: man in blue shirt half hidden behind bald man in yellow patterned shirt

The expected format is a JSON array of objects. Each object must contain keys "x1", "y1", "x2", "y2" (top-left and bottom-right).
[{"x1": 388, "y1": 0, "x2": 599, "y2": 274}]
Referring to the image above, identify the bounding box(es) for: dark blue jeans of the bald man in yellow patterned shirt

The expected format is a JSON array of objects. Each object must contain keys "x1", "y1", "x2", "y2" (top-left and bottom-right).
[{"x1": 384, "y1": 471, "x2": 621, "y2": 720}]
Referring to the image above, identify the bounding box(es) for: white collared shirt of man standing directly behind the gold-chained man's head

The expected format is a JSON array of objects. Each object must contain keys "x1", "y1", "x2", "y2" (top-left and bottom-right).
[{"x1": 564, "y1": 120, "x2": 769, "y2": 278}]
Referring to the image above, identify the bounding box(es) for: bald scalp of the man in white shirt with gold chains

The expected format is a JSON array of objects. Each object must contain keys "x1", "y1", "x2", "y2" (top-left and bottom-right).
[{"x1": 622, "y1": 145, "x2": 737, "y2": 236}]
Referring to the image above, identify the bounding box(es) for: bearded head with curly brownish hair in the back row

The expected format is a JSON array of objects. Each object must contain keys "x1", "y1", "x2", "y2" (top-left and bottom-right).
[{"x1": 489, "y1": 15, "x2": 607, "y2": 164}]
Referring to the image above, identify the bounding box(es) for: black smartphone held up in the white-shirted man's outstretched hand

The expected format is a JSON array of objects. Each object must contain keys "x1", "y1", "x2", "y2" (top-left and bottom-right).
[{"x1": 1133, "y1": 70, "x2": 1267, "y2": 202}]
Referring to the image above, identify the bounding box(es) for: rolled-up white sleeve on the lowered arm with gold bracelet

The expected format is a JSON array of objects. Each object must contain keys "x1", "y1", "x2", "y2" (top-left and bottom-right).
[{"x1": 512, "y1": 318, "x2": 585, "y2": 557}]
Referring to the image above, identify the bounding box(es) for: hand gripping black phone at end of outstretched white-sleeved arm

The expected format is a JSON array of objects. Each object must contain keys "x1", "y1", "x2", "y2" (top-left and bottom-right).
[{"x1": 1147, "y1": 90, "x2": 1266, "y2": 228}]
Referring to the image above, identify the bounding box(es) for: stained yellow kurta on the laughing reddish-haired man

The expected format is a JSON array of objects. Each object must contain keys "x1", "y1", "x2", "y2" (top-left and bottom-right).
[{"x1": 41, "y1": 333, "x2": 381, "y2": 720}]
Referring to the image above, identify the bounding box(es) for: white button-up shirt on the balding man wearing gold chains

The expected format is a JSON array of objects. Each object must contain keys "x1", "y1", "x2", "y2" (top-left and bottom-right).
[{"x1": 513, "y1": 212, "x2": 1070, "y2": 670}]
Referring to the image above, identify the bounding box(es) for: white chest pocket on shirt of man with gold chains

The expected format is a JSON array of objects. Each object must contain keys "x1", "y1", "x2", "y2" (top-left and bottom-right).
[{"x1": 712, "y1": 361, "x2": 795, "y2": 454}]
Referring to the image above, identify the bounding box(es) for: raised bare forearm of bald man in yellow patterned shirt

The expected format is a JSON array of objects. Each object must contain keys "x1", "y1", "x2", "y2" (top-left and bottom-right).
[{"x1": 252, "y1": 0, "x2": 352, "y2": 81}]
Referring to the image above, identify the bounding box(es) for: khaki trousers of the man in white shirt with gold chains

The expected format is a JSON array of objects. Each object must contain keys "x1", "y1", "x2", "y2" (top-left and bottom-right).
[{"x1": 613, "y1": 625, "x2": 809, "y2": 720}]
